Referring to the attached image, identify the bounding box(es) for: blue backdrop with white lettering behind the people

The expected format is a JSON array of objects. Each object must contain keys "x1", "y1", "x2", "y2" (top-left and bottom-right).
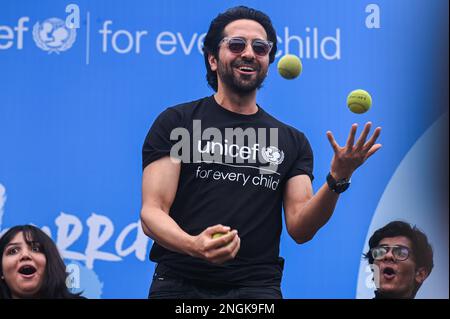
[{"x1": 0, "y1": 0, "x2": 448, "y2": 298}]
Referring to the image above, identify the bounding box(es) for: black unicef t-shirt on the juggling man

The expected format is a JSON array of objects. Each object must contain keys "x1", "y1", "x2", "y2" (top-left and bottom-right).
[{"x1": 142, "y1": 96, "x2": 313, "y2": 285}]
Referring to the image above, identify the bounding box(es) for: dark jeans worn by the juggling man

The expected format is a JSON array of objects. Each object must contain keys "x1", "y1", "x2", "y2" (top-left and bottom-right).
[{"x1": 148, "y1": 265, "x2": 283, "y2": 299}]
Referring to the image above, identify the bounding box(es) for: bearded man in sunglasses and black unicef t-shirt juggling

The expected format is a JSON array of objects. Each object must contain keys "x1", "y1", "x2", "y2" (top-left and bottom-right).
[{"x1": 141, "y1": 6, "x2": 381, "y2": 299}]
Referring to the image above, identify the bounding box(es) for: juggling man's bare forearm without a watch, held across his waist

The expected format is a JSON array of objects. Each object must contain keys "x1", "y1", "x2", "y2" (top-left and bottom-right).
[{"x1": 141, "y1": 208, "x2": 192, "y2": 255}]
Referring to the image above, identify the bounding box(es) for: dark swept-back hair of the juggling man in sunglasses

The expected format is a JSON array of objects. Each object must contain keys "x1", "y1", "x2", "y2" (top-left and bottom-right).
[{"x1": 203, "y1": 6, "x2": 277, "y2": 92}]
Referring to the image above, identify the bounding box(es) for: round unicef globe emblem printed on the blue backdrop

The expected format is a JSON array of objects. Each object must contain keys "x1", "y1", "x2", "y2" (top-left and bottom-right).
[{"x1": 33, "y1": 18, "x2": 77, "y2": 54}]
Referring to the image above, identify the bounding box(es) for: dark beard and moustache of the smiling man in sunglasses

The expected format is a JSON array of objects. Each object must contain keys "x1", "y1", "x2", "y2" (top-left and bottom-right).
[{"x1": 217, "y1": 60, "x2": 267, "y2": 95}]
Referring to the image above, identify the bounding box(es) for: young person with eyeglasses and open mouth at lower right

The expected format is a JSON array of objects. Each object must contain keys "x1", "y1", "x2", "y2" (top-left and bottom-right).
[{"x1": 365, "y1": 221, "x2": 433, "y2": 299}]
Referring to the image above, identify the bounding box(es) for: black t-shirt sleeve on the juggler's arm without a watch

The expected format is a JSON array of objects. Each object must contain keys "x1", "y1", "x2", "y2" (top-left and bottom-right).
[{"x1": 142, "y1": 108, "x2": 183, "y2": 169}]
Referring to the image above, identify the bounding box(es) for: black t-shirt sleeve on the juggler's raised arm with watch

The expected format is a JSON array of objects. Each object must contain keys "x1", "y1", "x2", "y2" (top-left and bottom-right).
[{"x1": 286, "y1": 132, "x2": 314, "y2": 181}]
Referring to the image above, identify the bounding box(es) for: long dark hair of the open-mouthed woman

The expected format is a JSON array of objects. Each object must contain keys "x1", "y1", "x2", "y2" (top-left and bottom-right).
[{"x1": 0, "y1": 225, "x2": 79, "y2": 299}]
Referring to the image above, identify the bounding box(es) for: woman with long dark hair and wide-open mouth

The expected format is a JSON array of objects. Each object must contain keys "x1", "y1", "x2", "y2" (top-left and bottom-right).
[{"x1": 0, "y1": 225, "x2": 84, "y2": 299}]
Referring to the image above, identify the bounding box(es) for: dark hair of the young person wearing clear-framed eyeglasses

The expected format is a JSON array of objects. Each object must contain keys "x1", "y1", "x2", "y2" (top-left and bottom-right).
[{"x1": 364, "y1": 221, "x2": 434, "y2": 292}]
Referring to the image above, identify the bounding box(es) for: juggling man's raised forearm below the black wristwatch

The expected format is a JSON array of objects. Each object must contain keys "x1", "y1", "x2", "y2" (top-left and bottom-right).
[{"x1": 291, "y1": 183, "x2": 339, "y2": 243}]
